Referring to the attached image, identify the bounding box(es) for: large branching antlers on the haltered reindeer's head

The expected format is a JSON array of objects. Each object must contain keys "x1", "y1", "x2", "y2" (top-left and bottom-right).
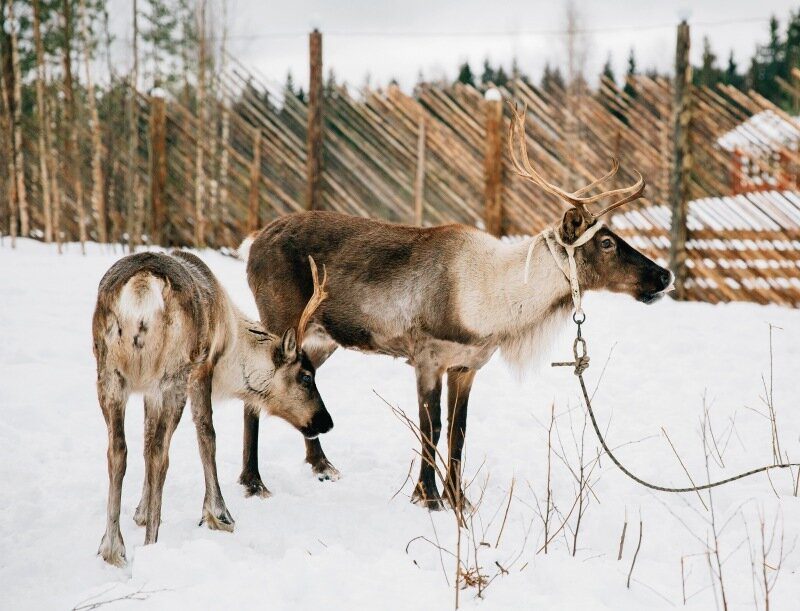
[{"x1": 508, "y1": 105, "x2": 645, "y2": 220}]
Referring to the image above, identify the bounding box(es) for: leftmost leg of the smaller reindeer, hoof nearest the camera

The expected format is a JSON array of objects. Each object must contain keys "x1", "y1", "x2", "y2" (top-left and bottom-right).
[{"x1": 97, "y1": 372, "x2": 128, "y2": 566}]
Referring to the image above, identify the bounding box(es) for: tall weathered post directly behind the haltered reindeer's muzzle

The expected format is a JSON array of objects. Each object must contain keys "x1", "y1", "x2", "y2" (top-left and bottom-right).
[{"x1": 669, "y1": 20, "x2": 692, "y2": 299}]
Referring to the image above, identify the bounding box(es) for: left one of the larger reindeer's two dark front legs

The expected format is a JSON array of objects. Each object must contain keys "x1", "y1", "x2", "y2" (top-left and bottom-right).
[{"x1": 411, "y1": 366, "x2": 444, "y2": 511}]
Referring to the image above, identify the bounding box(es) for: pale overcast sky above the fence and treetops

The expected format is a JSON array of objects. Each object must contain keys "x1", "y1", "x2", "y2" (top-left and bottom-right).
[{"x1": 111, "y1": 0, "x2": 800, "y2": 88}]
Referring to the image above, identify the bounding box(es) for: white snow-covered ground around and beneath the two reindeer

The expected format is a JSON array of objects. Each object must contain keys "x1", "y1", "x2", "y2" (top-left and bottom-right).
[{"x1": 0, "y1": 240, "x2": 800, "y2": 610}]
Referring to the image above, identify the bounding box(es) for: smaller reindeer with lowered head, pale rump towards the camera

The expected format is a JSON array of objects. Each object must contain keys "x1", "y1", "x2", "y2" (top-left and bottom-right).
[{"x1": 92, "y1": 251, "x2": 333, "y2": 566}]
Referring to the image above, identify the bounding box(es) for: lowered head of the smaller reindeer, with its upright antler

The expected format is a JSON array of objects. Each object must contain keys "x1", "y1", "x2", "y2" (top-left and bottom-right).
[{"x1": 245, "y1": 257, "x2": 333, "y2": 439}]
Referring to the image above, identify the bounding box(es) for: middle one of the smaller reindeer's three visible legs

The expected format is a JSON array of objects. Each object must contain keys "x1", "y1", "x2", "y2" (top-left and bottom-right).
[{"x1": 144, "y1": 375, "x2": 186, "y2": 545}]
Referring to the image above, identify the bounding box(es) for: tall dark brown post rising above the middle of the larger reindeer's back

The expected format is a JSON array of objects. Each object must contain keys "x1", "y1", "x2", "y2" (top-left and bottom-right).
[{"x1": 306, "y1": 29, "x2": 322, "y2": 210}]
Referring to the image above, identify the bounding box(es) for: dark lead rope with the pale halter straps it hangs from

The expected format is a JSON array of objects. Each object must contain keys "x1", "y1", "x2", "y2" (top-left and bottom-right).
[{"x1": 548, "y1": 228, "x2": 800, "y2": 492}]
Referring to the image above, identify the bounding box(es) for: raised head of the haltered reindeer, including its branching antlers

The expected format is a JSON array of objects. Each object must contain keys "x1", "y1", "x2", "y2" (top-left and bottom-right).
[{"x1": 509, "y1": 107, "x2": 673, "y2": 303}]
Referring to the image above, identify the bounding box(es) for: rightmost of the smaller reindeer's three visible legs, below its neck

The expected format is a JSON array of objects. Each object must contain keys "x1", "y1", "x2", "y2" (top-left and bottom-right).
[{"x1": 191, "y1": 375, "x2": 234, "y2": 532}]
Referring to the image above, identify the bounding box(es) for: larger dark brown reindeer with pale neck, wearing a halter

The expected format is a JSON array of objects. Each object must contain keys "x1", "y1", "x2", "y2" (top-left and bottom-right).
[{"x1": 240, "y1": 111, "x2": 672, "y2": 509}]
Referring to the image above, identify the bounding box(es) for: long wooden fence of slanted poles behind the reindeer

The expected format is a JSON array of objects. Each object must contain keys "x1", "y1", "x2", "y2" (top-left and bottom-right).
[{"x1": 0, "y1": 29, "x2": 800, "y2": 307}]
